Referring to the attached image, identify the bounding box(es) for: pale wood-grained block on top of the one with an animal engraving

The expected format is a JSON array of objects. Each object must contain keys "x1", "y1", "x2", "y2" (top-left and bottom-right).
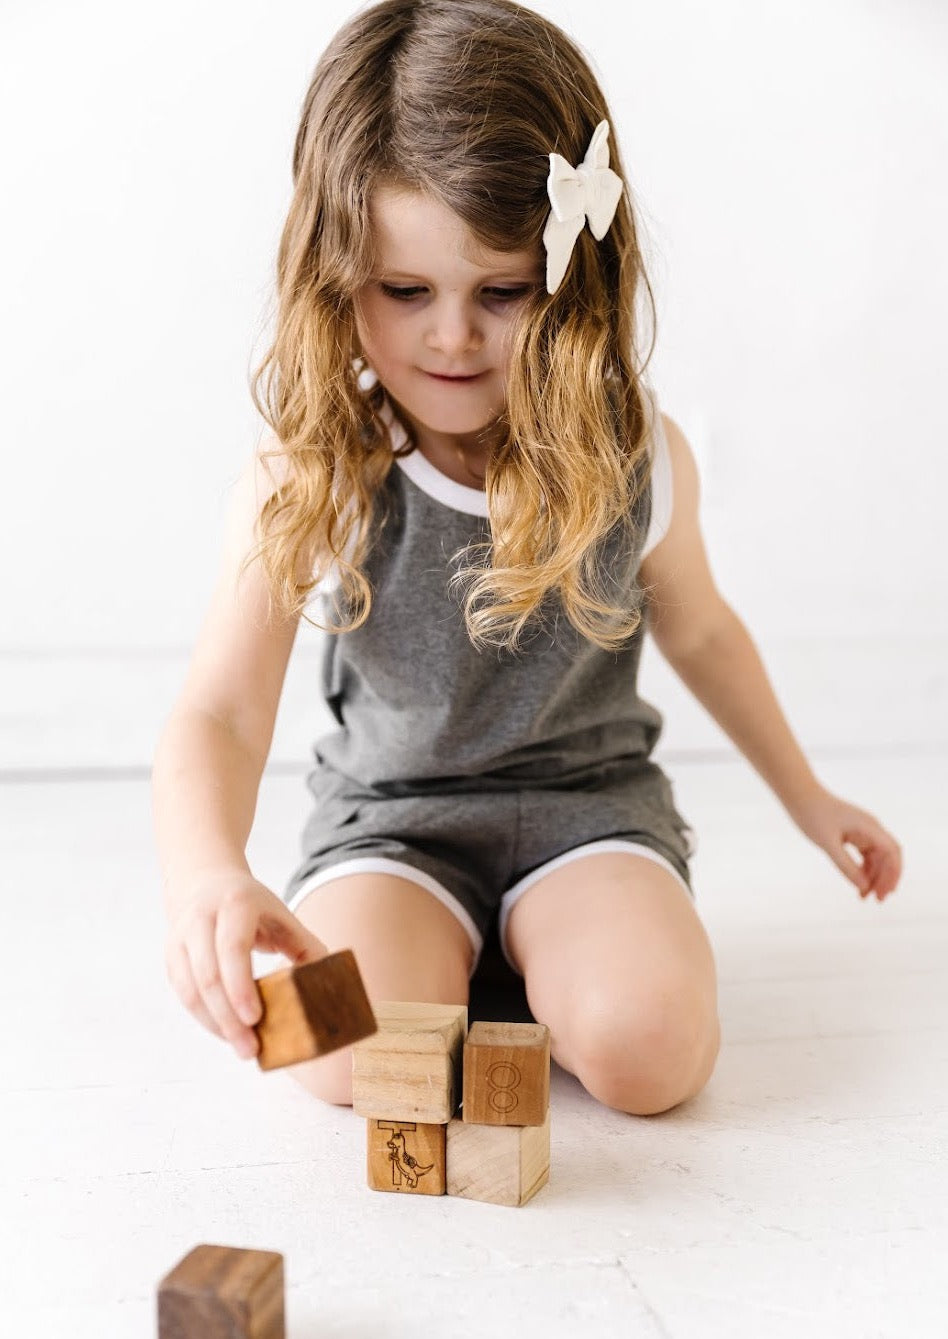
[{"x1": 352, "y1": 1000, "x2": 467, "y2": 1125}]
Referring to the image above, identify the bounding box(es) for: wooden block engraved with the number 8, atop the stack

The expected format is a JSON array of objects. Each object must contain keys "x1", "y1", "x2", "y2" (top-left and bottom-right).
[{"x1": 462, "y1": 1022, "x2": 550, "y2": 1125}]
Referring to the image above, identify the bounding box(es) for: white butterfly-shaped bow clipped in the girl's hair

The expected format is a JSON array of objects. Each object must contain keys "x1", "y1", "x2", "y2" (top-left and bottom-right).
[{"x1": 544, "y1": 121, "x2": 623, "y2": 293}]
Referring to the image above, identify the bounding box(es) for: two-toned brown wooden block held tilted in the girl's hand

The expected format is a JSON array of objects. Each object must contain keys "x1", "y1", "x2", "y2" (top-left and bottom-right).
[{"x1": 254, "y1": 948, "x2": 376, "y2": 1070}]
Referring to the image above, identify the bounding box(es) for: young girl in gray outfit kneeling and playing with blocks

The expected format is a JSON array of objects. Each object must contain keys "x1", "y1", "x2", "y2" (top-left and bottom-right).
[{"x1": 154, "y1": 0, "x2": 901, "y2": 1114}]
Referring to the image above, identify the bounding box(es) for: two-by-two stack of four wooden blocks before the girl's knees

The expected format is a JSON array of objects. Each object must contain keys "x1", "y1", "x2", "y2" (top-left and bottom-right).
[{"x1": 352, "y1": 1002, "x2": 550, "y2": 1205}]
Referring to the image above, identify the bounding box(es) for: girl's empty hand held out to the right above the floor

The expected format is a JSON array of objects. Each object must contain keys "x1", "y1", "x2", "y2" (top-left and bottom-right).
[{"x1": 793, "y1": 786, "x2": 902, "y2": 902}]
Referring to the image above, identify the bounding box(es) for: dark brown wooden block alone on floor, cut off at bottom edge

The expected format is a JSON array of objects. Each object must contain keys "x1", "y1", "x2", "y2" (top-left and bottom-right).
[{"x1": 158, "y1": 1245, "x2": 287, "y2": 1339}]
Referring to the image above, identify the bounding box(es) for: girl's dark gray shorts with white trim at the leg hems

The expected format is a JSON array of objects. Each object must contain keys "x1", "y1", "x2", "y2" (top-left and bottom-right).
[{"x1": 284, "y1": 762, "x2": 695, "y2": 973}]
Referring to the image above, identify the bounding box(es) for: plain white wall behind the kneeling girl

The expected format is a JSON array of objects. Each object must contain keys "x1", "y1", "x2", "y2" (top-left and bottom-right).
[{"x1": 0, "y1": 0, "x2": 948, "y2": 771}]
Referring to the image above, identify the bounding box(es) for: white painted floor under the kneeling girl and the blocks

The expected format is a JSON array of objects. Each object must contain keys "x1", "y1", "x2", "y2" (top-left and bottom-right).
[{"x1": 0, "y1": 757, "x2": 948, "y2": 1339}]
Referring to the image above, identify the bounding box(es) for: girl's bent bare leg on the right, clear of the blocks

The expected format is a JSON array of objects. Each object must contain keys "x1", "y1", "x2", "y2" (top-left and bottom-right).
[{"x1": 506, "y1": 852, "x2": 720, "y2": 1115}]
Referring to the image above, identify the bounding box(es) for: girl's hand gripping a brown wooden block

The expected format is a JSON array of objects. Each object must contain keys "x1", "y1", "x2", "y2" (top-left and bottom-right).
[{"x1": 165, "y1": 869, "x2": 329, "y2": 1059}]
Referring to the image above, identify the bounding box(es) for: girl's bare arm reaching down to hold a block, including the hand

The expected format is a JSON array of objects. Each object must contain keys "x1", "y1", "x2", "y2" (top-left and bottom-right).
[{"x1": 153, "y1": 449, "x2": 327, "y2": 1055}]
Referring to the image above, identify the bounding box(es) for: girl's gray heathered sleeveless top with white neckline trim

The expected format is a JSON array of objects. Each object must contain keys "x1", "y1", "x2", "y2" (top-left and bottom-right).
[{"x1": 303, "y1": 390, "x2": 669, "y2": 799}]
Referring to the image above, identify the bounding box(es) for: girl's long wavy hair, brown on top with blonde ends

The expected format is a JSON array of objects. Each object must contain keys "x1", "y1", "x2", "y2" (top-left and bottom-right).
[{"x1": 248, "y1": 0, "x2": 655, "y2": 649}]
